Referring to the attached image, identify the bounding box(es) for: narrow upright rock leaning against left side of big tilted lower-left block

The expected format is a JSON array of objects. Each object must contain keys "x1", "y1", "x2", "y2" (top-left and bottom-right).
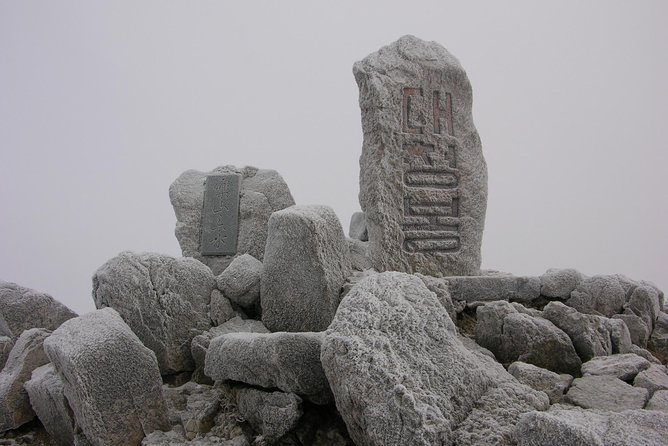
[{"x1": 24, "y1": 364, "x2": 75, "y2": 446}]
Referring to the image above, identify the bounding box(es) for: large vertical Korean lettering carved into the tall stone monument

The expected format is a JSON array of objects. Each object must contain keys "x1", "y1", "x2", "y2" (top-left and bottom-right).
[{"x1": 401, "y1": 87, "x2": 460, "y2": 253}]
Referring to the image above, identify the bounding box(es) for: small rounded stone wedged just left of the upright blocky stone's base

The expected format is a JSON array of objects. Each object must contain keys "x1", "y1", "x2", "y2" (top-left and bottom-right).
[{"x1": 216, "y1": 254, "x2": 262, "y2": 312}]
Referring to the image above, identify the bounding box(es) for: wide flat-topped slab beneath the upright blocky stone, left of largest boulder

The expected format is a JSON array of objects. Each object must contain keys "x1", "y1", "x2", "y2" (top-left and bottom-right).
[{"x1": 204, "y1": 332, "x2": 332, "y2": 404}]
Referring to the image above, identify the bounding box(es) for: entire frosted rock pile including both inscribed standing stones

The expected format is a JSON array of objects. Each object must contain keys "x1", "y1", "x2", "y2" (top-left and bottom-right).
[{"x1": 0, "y1": 36, "x2": 668, "y2": 446}]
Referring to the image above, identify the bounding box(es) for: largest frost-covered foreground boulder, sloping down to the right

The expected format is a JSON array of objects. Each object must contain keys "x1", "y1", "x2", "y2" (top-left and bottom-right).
[{"x1": 321, "y1": 272, "x2": 549, "y2": 445}]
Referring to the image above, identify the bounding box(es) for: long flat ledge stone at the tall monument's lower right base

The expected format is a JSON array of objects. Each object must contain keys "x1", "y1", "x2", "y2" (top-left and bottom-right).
[{"x1": 443, "y1": 276, "x2": 540, "y2": 302}]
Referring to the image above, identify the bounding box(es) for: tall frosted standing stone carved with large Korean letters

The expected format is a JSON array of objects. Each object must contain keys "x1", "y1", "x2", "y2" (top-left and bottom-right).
[{"x1": 353, "y1": 36, "x2": 487, "y2": 276}]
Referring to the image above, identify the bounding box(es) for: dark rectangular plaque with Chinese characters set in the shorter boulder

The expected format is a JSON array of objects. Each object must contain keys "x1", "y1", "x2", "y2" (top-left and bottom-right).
[{"x1": 200, "y1": 174, "x2": 241, "y2": 256}]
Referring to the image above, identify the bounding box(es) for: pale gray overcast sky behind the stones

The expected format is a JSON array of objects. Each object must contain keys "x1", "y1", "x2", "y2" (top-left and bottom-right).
[{"x1": 0, "y1": 0, "x2": 668, "y2": 312}]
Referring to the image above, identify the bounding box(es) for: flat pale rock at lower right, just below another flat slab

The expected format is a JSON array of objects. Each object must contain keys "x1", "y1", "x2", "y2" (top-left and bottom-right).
[{"x1": 562, "y1": 375, "x2": 647, "y2": 412}]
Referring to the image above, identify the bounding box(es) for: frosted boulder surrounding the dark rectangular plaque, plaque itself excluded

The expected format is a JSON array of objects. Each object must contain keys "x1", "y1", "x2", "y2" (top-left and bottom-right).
[{"x1": 169, "y1": 166, "x2": 295, "y2": 275}]
